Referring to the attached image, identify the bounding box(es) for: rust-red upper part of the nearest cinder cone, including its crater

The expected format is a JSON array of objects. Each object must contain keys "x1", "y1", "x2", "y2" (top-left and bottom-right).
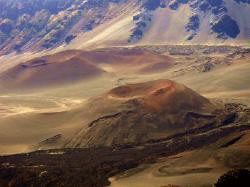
[{"x1": 108, "y1": 80, "x2": 209, "y2": 112}]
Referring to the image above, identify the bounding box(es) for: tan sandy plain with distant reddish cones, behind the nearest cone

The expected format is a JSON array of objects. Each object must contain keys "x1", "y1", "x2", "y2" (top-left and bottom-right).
[{"x1": 0, "y1": 46, "x2": 250, "y2": 154}]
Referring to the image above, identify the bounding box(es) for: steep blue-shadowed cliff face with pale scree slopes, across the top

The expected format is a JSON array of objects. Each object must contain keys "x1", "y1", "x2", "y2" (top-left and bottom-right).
[{"x1": 0, "y1": 0, "x2": 250, "y2": 54}]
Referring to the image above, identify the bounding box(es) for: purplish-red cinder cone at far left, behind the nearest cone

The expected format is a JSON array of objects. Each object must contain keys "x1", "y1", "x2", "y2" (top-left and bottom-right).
[{"x1": 0, "y1": 57, "x2": 104, "y2": 87}]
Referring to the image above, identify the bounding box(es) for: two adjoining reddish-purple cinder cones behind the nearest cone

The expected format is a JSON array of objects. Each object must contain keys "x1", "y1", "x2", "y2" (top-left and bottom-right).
[{"x1": 0, "y1": 48, "x2": 172, "y2": 88}]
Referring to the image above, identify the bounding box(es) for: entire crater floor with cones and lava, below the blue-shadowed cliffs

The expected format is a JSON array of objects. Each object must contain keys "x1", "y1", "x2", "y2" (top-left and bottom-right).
[{"x1": 0, "y1": 45, "x2": 250, "y2": 187}]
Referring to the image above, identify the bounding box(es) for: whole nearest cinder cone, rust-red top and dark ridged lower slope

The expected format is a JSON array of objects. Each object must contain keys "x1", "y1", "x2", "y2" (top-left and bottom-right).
[{"x1": 67, "y1": 80, "x2": 215, "y2": 147}]
